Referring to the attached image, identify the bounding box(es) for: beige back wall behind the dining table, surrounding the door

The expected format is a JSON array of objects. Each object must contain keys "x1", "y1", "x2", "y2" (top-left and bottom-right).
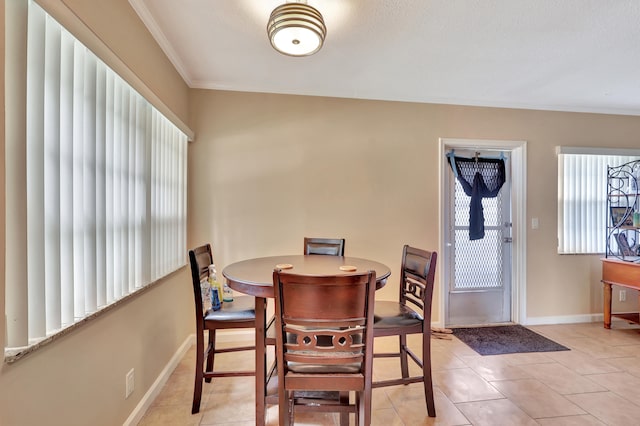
[{"x1": 189, "y1": 90, "x2": 640, "y2": 322}]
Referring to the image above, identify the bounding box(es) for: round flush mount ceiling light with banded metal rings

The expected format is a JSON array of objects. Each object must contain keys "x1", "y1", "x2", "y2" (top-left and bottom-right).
[{"x1": 267, "y1": 3, "x2": 327, "y2": 56}]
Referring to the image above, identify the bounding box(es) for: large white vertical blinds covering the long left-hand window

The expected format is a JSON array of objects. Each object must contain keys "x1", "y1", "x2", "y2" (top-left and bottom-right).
[{"x1": 7, "y1": 2, "x2": 187, "y2": 346}]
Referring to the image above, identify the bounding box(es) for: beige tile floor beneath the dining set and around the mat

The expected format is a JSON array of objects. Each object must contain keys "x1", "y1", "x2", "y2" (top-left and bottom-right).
[{"x1": 139, "y1": 319, "x2": 640, "y2": 426}]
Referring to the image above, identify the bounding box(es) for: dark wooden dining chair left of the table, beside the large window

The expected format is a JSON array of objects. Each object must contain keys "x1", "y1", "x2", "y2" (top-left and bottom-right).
[{"x1": 189, "y1": 244, "x2": 256, "y2": 414}]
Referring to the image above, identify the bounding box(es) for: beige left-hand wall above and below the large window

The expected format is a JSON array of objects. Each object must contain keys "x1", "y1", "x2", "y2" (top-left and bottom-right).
[{"x1": 0, "y1": 0, "x2": 194, "y2": 426}]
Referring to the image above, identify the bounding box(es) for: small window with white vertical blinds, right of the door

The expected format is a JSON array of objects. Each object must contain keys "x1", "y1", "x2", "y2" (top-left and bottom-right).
[{"x1": 557, "y1": 147, "x2": 640, "y2": 254}]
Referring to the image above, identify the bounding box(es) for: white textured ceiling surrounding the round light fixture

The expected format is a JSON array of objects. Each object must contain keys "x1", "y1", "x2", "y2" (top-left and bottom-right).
[{"x1": 129, "y1": 0, "x2": 640, "y2": 115}]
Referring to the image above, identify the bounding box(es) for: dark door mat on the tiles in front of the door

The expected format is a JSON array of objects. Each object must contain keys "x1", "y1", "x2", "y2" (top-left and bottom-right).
[{"x1": 453, "y1": 325, "x2": 570, "y2": 355}]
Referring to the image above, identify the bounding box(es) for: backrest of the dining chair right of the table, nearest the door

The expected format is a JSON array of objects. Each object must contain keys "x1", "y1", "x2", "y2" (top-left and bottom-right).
[{"x1": 400, "y1": 245, "x2": 438, "y2": 322}]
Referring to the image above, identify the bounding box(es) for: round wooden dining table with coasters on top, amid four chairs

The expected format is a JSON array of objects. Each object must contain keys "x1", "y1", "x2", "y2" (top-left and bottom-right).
[{"x1": 222, "y1": 254, "x2": 391, "y2": 426}]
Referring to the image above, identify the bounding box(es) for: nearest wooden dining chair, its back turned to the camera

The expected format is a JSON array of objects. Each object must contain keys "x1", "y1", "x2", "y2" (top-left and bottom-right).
[{"x1": 273, "y1": 270, "x2": 376, "y2": 425}]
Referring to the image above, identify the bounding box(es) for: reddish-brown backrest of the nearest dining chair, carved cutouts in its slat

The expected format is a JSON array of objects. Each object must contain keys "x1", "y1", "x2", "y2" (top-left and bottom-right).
[{"x1": 273, "y1": 270, "x2": 376, "y2": 372}]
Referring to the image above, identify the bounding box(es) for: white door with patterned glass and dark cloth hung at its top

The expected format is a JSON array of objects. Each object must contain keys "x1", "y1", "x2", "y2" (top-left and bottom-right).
[{"x1": 443, "y1": 148, "x2": 512, "y2": 326}]
